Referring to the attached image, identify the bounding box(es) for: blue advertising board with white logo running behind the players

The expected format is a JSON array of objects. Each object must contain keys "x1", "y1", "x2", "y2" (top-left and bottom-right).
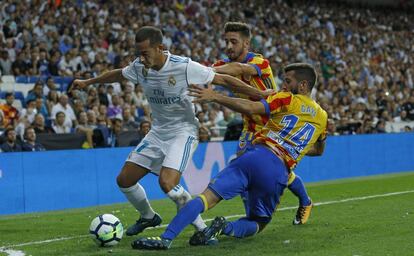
[{"x1": 0, "y1": 133, "x2": 414, "y2": 215}]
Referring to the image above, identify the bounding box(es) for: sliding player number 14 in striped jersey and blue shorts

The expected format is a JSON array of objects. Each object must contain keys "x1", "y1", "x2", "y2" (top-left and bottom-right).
[{"x1": 132, "y1": 63, "x2": 327, "y2": 250}]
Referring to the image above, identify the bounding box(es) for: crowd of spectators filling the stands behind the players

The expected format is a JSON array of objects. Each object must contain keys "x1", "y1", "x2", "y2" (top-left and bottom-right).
[{"x1": 0, "y1": 0, "x2": 414, "y2": 151}]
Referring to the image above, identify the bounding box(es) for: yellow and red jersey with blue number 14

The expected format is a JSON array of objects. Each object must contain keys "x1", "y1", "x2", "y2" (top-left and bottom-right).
[{"x1": 253, "y1": 92, "x2": 328, "y2": 170}]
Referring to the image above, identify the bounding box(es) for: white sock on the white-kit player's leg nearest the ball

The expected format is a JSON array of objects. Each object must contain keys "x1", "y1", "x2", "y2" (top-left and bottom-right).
[{"x1": 119, "y1": 183, "x2": 155, "y2": 219}]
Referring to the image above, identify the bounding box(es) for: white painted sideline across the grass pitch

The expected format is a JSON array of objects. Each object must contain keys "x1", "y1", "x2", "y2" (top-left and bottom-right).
[{"x1": 0, "y1": 190, "x2": 414, "y2": 251}]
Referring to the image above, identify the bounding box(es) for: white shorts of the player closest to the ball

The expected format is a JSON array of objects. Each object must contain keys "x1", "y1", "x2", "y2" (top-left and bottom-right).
[{"x1": 126, "y1": 130, "x2": 198, "y2": 175}]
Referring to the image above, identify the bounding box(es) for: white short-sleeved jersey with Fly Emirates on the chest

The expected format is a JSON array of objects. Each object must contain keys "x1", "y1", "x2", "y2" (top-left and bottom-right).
[{"x1": 122, "y1": 51, "x2": 215, "y2": 133}]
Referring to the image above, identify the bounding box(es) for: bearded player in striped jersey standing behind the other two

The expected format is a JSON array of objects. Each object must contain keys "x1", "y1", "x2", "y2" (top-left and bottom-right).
[{"x1": 213, "y1": 22, "x2": 312, "y2": 225}]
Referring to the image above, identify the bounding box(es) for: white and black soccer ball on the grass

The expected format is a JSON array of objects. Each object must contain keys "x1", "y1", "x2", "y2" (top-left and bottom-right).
[{"x1": 89, "y1": 214, "x2": 124, "y2": 246}]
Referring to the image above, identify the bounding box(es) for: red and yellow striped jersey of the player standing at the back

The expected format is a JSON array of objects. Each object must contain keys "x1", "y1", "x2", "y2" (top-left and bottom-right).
[{"x1": 213, "y1": 52, "x2": 277, "y2": 135}]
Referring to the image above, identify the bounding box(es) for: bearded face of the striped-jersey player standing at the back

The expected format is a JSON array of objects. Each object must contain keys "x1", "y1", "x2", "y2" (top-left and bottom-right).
[{"x1": 224, "y1": 32, "x2": 249, "y2": 61}]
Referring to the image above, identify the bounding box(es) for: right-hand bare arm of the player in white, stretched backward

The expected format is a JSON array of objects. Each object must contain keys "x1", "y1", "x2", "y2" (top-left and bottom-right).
[{"x1": 212, "y1": 73, "x2": 275, "y2": 100}]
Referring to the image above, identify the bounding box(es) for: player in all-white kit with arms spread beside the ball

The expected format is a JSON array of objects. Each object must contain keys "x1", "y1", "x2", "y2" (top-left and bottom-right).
[{"x1": 73, "y1": 26, "x2": 269, "y2": 240}]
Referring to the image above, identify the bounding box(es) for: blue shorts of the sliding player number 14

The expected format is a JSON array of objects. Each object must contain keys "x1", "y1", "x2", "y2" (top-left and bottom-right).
[{"x1": 208, "y1": 145, "x2": 288, "y2": 223}]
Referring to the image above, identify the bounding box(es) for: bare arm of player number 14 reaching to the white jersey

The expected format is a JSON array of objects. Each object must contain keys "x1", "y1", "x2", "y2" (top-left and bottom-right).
[{"x1": 188, "y1": 85, "x2": 266, "y2": 115}]
